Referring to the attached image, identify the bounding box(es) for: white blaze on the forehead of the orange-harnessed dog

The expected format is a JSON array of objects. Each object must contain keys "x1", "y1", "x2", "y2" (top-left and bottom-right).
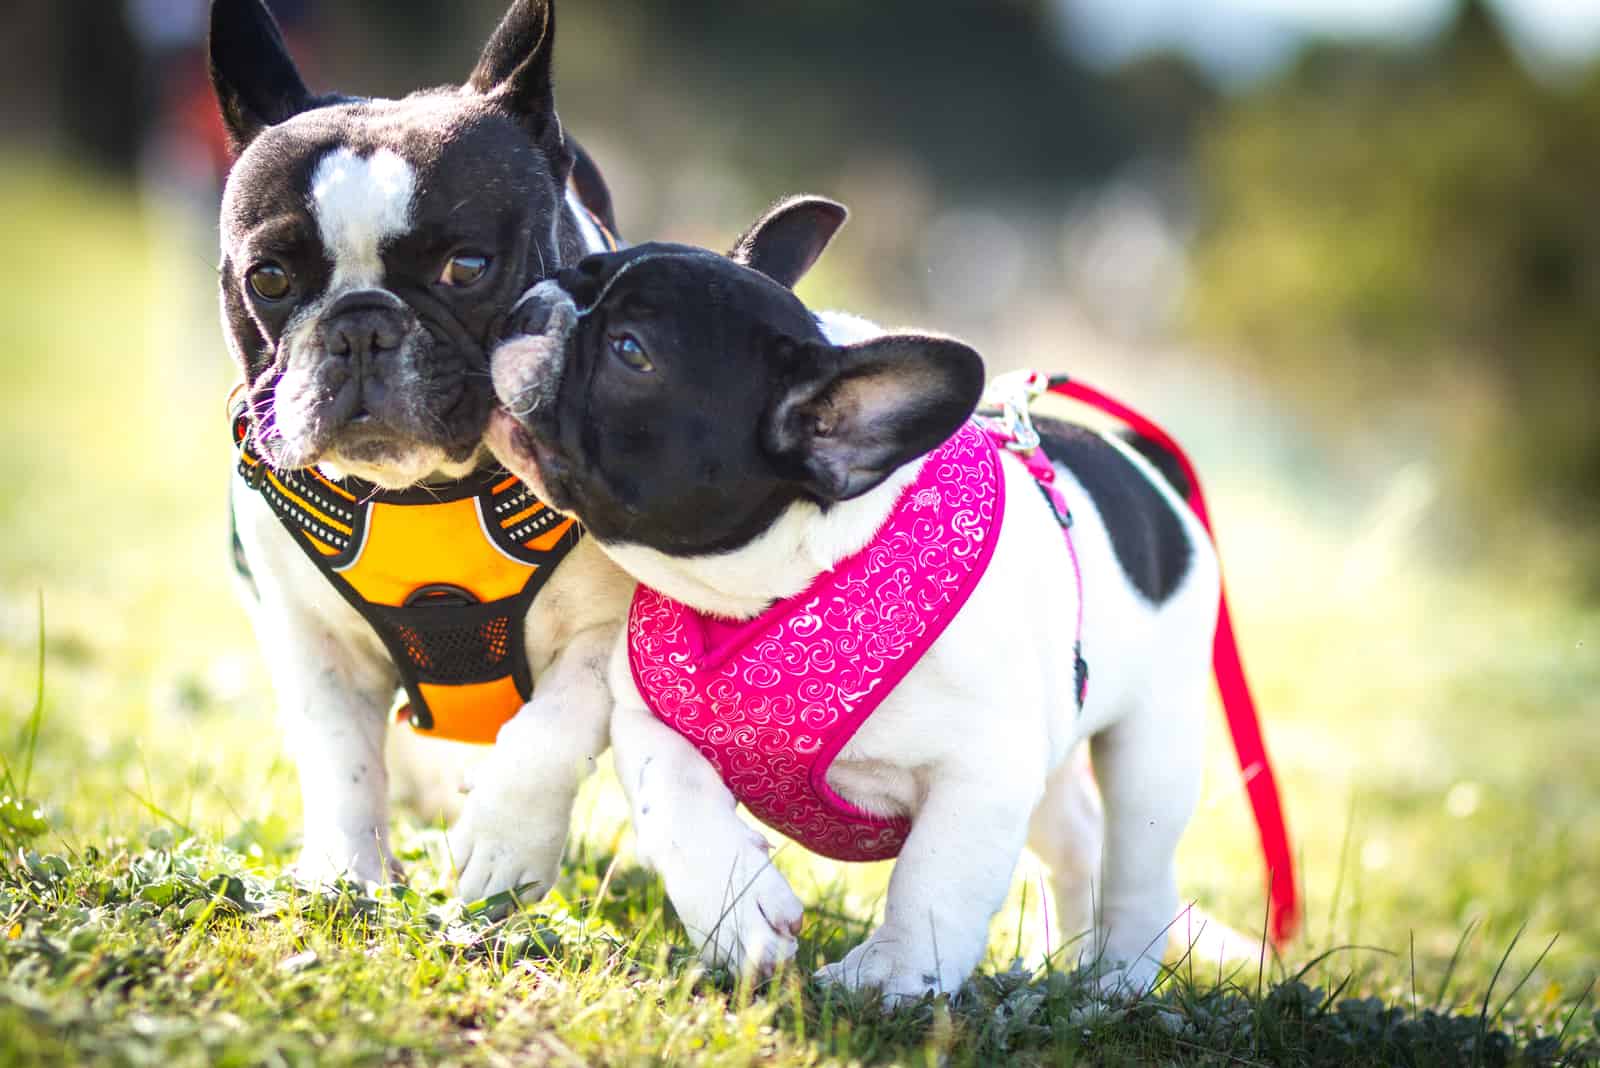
[{"x1": 310, "y1": 149, "x2": 416, "y2": 293}]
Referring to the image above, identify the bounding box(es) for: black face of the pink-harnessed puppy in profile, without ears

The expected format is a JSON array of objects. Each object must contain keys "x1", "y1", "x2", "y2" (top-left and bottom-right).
[{"x1": 488, "y1": 245, "x2": 827, "y2": 556}]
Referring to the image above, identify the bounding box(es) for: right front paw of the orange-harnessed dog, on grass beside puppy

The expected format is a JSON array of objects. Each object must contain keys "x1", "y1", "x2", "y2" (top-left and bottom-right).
[{"x1": 448, "y1": 787, "x2": 566, "y2": 905}]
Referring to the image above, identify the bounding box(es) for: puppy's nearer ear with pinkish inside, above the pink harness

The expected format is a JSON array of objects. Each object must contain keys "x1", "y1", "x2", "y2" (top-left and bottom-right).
[{"x1": 763, "y1": 334, "x2": 984, "y2": 500}]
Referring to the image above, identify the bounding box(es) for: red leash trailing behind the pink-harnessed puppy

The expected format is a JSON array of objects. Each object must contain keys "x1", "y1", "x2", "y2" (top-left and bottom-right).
[{"x1": 1046, "y1": 374, "x2": 1299, "y2": 945}]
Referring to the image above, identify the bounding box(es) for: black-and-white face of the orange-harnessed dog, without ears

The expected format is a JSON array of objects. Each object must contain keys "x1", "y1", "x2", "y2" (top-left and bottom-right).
[{"x1": 221, "y1": 90, "x2": 563, "y2": 488}]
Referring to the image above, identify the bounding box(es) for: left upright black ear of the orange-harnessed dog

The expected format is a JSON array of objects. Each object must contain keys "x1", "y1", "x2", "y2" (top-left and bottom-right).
[{"x1": 210, "y1": 0, "x2": 312, "y2": 153}]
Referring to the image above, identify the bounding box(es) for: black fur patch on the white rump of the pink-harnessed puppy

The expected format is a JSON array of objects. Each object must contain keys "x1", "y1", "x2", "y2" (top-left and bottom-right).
[{"x1": 1034, "y1": 419, "x2": 1194, "y2": 604}]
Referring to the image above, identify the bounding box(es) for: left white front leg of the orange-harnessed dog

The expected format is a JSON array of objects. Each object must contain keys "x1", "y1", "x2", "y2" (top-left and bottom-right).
[{"x1": 256, "y1": 604, "x2": 400, "y2": 883}]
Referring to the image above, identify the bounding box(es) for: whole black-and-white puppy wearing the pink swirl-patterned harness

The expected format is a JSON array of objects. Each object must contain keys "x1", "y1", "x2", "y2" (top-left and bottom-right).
[{"x1": 486, "y1": 198, "x2": 1286, "y2": 996}]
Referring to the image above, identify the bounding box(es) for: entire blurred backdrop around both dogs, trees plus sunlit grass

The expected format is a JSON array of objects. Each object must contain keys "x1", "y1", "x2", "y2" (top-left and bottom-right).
[{"x1": 0, "y1": 0, "x2": 1600, "y2": 983}]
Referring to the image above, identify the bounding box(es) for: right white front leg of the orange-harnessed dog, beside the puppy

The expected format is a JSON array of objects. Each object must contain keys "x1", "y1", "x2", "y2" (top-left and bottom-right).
[{"x1": 450, "y1": 625, "x2": 616, "y2": 902}]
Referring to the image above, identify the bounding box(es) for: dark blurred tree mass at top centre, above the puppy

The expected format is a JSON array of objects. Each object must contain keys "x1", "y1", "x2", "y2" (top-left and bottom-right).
[{"x1": 601, "y1": 0, "x2": 1144, "y2": 189}]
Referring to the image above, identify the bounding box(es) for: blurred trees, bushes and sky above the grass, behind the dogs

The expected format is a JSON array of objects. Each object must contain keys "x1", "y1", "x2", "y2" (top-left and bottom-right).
[{"x1": 12, "y1": 0, "x2": 1600, "y2": 559}]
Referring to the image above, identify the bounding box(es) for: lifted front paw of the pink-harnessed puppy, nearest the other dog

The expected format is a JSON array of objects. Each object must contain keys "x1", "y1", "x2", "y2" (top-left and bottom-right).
[{"x1": 675, "y1": 847, "x2": 805, "y2": 978}]
